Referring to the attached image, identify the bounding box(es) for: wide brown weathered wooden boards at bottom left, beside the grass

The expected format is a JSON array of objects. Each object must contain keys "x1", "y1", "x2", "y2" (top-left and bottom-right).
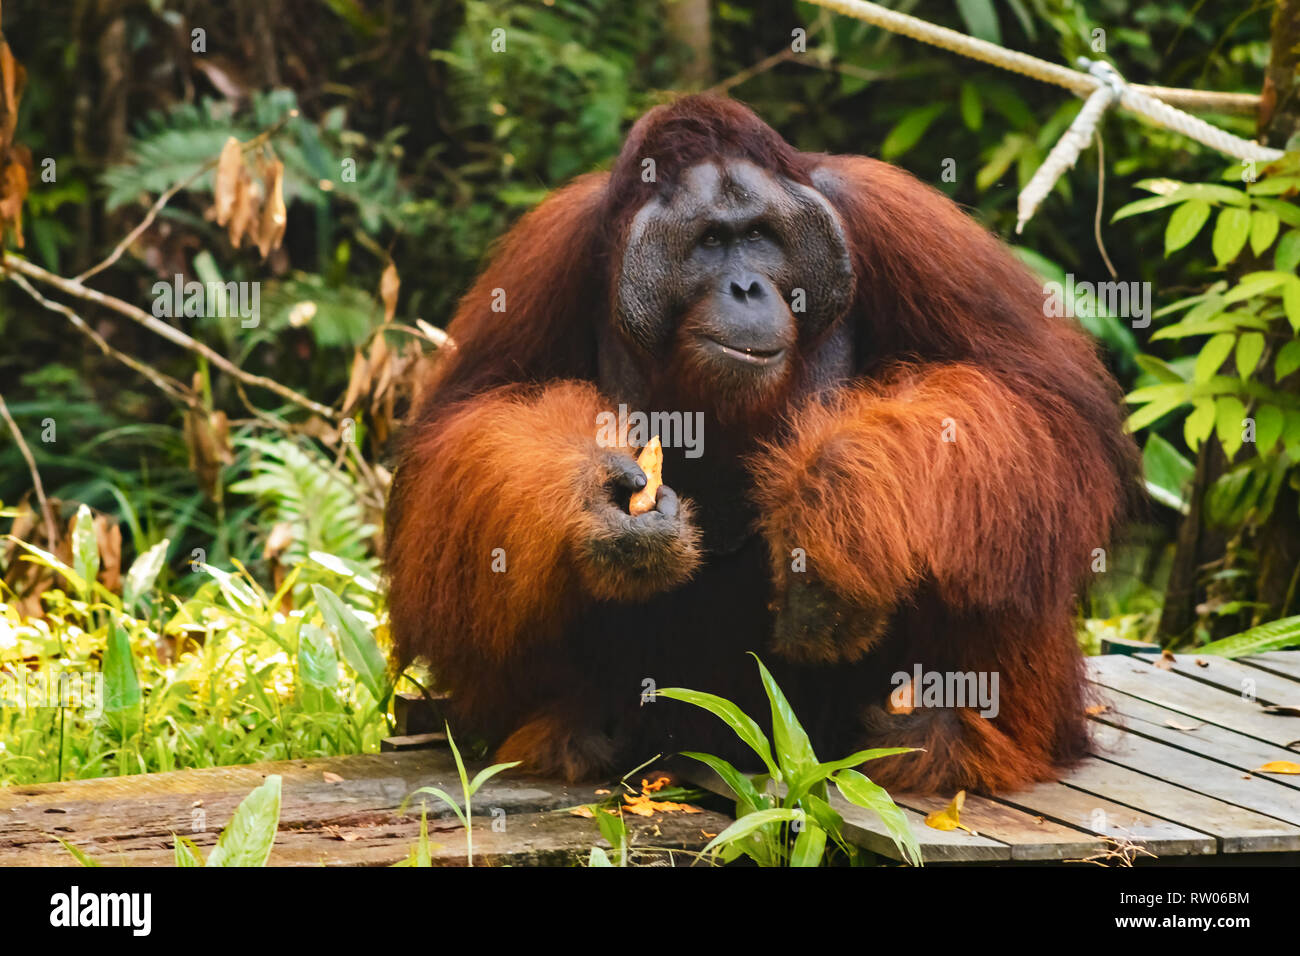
[{"x1": 0, "y1": 749, "x2": 729, "y2": 866}]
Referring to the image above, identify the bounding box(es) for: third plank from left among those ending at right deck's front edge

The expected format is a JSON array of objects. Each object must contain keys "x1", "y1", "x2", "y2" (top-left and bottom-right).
[{"x1": 996, "y1": 780, "x2": 1218, "y2": 857}]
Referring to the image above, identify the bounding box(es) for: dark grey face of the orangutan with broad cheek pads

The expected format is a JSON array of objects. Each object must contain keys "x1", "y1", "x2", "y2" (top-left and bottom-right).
[{"x1": 616, "y1": 160, "x2": 853, "y2": 411}]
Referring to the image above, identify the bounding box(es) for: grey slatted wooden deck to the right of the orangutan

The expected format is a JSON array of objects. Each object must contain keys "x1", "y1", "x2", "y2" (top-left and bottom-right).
[{"x1": 699, "y1": 652, "x2": 1300, "y2": 865}]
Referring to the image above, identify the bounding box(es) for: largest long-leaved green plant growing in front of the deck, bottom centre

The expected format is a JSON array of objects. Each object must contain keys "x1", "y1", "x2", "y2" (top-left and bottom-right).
[{"x1": 657, "y1": 654, "x2": 922, "y2": 866}]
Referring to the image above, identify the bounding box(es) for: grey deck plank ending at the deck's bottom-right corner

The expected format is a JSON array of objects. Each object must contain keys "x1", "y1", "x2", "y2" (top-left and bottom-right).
[{"x1": 1062, "y1": 760, "x2": 1300, "y2": 853}]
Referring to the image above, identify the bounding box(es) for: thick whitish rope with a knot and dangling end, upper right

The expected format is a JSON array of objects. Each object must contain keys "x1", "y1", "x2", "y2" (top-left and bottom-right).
[{"x1": 809, "y1": 0, "x2": 1283, "y2": 232}]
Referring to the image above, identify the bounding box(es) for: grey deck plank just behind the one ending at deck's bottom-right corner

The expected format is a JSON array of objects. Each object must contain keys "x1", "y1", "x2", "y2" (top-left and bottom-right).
[{"x1": 1092, "y1": 726, "x2": 1300, "y2": 827}]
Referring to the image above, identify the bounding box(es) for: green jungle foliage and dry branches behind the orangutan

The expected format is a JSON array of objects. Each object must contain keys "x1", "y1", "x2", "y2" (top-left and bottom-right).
[{"x1": 0, "y1": 0, "x2": 1300, "y2": 784}]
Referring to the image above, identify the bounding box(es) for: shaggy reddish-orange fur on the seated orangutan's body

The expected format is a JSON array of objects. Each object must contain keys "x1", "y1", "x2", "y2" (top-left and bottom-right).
[{"x1": 386, "y1": 96, "x2": 1136, "y2": 791}]
